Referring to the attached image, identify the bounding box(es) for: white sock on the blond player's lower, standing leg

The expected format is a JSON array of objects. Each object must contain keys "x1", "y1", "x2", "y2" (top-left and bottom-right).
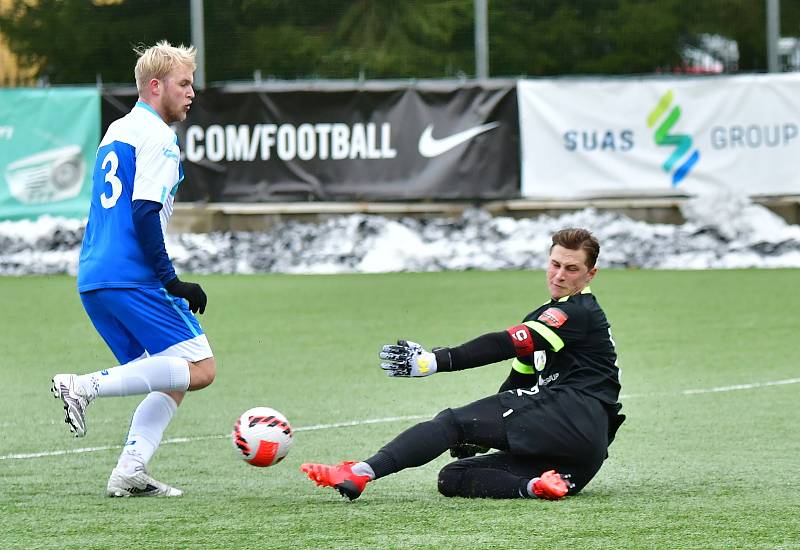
[{"x1": 117, "y1": 392, "x2": 178, "y2": 474}]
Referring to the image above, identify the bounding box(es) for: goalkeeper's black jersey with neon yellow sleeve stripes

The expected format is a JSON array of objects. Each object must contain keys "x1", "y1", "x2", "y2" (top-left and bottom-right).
[{"x1": 500, "y1": 287, "x2": 620, "y2": 406}]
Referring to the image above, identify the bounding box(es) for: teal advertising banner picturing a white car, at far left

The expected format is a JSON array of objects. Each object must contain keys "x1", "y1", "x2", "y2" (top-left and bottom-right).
[{"x1": 0, "y1": 88, "x2": 100, "y2": 219}]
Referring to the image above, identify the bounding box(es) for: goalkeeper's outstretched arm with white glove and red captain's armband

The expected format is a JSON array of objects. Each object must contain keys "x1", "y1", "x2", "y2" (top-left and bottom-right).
[{"x1": 380, "y1": 325, "x2": 535, "y2": 378}]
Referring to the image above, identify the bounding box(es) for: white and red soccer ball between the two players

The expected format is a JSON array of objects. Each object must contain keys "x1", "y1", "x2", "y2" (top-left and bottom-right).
[{"x1": 231, "y1": 407, "x2": 292, "y2": 466}]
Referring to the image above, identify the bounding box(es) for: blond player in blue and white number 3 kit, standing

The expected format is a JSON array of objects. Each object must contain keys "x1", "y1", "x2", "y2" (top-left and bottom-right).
[{"x1": 52, "y1": 41, "x2": 216, "y2": 497}]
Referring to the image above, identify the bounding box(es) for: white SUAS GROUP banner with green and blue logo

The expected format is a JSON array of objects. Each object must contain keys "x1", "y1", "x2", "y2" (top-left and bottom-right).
[{"x1": 517, "y1": 73, "x2": 800, "y2": 199}]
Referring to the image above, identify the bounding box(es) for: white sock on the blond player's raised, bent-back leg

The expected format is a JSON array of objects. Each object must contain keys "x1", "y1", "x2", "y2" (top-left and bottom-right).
[{"x1": 77, "y1": 356, "x2": 189, "y2": 399}]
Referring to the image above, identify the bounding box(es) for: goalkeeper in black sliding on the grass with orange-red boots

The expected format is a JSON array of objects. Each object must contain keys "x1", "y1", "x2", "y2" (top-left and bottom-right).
[{"x1": 300, "y1": 228, "x2": 625, "y2": 500}]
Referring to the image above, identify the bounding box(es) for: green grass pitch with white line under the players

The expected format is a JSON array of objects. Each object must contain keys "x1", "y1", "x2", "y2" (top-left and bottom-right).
[{"x1": 0, "y1": 270, "x2": 800, "y2": 549}]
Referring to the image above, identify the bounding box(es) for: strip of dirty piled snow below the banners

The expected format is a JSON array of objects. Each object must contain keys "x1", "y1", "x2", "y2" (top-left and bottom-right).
[{"x1": 0, "y1": 195, "x2": 800, "y2": 275}]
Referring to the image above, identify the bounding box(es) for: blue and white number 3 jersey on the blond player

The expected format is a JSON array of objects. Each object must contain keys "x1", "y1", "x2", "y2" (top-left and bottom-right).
[{"x1": 78, "y1": 101, "x2": 183, "y2": 292}]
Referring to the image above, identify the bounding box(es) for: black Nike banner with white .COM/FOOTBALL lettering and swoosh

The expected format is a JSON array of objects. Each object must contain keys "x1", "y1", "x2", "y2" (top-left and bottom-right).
[{"x1": 148, "y1": 81, "x2": 520, "y2": 202}]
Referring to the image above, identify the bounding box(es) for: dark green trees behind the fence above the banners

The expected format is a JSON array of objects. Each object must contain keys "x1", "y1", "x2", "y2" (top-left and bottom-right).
[{"x1": 0, "y1": 0, "x2": 800, "y2": 84}]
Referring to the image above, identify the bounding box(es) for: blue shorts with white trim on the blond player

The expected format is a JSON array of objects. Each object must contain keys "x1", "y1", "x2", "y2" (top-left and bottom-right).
[{"x1": 81, "y1": 288, "x2": 213, "y2": 365}]
